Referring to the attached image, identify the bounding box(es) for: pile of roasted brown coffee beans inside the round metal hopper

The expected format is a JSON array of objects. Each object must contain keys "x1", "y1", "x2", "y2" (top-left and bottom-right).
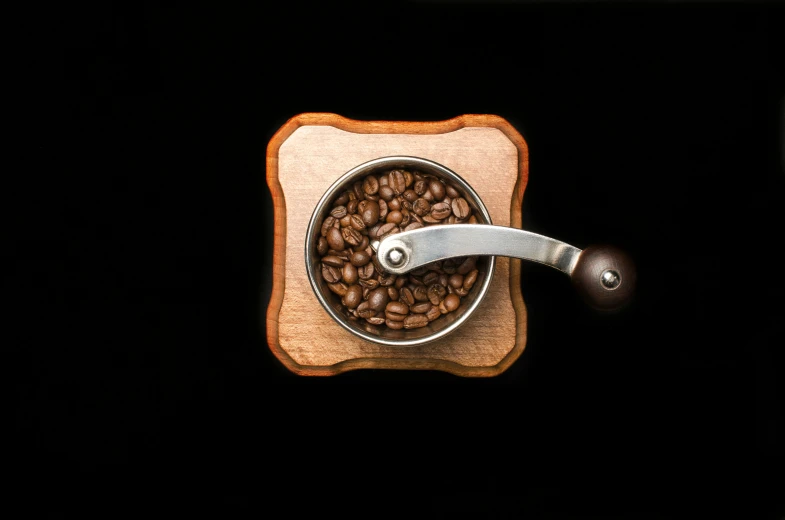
[{"x1": 316, "y1": 168, "x2": 478, "y2": 330}]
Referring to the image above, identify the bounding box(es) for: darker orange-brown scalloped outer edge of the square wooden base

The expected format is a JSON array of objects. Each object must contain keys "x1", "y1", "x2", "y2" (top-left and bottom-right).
[{"x1": 266, "y1": 112, "x2": 529, "y2": 377}]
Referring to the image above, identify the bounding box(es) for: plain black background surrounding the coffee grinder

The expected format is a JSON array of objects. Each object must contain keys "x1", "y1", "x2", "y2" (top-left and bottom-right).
[{"x1": 16, "y1": 1, "x2": 785, "y2": 519}]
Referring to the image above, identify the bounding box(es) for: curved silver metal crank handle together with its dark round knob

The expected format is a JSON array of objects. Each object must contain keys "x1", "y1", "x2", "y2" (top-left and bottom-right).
[{"x1": 371, "y1": 224, "x2": 636, "y2": 311}]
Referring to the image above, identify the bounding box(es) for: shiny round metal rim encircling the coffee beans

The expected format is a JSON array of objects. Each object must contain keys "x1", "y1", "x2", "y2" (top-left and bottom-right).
[{"x1": 305, "y1": 155, "x2": 496, "y2": 347}]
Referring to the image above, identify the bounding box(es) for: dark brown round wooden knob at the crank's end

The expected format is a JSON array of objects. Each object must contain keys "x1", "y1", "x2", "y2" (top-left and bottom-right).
[{"x1": 572, "y1": 245, "x2": 637, "y2": 311}]
